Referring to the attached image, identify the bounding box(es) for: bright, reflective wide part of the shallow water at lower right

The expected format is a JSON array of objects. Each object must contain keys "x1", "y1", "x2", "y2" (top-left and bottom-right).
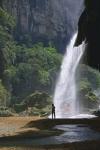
[{"x1": 56, "y1": 125, "x2": 100, "y2": 143}]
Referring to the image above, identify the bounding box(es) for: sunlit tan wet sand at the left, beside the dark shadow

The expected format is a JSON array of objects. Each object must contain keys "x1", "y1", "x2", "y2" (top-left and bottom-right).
[{"x1": 0, "y1": 117, "x2": 40, "y2": 138}]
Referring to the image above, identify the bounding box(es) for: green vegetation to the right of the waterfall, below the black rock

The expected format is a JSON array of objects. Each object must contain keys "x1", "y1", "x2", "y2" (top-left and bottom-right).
[{"x1": 77, "y1": 65, "x2": 100, "y2": 112}]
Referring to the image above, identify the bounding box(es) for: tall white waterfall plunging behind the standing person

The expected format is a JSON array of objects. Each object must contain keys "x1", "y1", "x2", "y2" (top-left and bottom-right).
[{"x1": 54, "y1": 33, "x2": 85, "y2": 118}]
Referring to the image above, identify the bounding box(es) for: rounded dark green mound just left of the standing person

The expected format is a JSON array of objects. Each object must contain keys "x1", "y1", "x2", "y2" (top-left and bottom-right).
[{"x1": 14, "y1": 91, "x2": 52, "y2": 116}]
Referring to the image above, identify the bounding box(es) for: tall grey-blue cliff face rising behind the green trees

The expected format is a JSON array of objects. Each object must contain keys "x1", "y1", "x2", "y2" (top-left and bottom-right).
[{"x1": 0, "y1": 0, "x2": 83, "y2": 50}]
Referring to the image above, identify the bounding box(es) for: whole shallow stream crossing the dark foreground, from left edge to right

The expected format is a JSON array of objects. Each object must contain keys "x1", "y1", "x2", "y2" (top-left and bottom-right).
[{"x1": 0, "y1": 125, "x2": 100, "y2": 150}]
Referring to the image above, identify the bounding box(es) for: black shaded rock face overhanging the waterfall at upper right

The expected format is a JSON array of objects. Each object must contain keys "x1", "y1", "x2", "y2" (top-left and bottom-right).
[{"x1": 77, "y1": 0, "x2": 100, "y2": 68}]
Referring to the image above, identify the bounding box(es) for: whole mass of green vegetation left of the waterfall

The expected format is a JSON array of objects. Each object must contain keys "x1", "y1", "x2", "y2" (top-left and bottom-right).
[{"x1": 0, "y1": 8, "x2": 62, "y2": 114}]
